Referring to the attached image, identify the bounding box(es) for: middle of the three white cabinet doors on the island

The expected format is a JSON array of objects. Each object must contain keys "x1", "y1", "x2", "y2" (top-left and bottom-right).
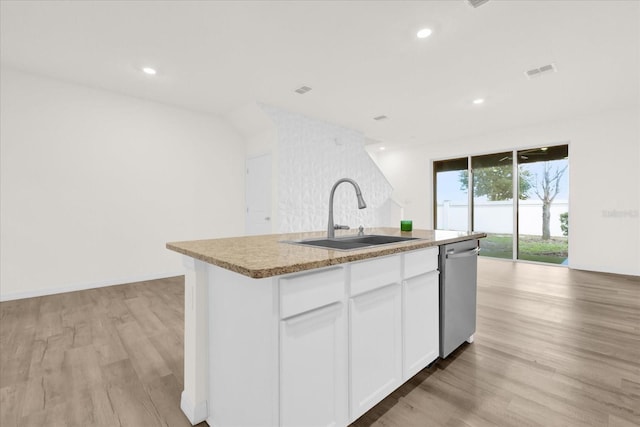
[{"x1": 349, "y1": 283, "x2": 402, "y2": 421}]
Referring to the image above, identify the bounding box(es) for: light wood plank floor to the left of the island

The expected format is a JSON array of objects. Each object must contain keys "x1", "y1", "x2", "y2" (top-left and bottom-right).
[{"x1": 0, "y1": 277, "x2": 206, "y2": 427}]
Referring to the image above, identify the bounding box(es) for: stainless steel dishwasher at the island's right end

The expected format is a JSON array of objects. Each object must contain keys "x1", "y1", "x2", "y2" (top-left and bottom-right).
[{"x1": 439, "y1": 239, "x2": 480, "y2": 359}]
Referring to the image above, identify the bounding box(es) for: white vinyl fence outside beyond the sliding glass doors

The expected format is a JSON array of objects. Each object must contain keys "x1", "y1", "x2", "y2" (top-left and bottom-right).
[{"x1": 436, "y1": 199, "x2": 571, "y2": 236}]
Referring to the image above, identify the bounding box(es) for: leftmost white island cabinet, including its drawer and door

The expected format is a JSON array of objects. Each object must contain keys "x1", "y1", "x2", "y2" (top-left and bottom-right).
[{"x1": 279, "y1": 267, "x2": 349, "y2": 427}]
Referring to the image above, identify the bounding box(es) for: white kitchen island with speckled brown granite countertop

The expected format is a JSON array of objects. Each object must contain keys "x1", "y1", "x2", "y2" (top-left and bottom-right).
[{"x1": 167, "y1": 228, "x2": 485, "y2": 427}]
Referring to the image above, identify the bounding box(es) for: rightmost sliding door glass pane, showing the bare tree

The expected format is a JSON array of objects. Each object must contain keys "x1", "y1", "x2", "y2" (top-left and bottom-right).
[{"x1": 518, "y1": 145, "x2": 569, "y2": 264}]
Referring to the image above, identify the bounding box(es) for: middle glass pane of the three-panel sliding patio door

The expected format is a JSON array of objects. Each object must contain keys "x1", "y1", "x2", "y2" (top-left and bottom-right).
[{"x1": 471, "y1": 152, "x2": 513, "y2": 259}]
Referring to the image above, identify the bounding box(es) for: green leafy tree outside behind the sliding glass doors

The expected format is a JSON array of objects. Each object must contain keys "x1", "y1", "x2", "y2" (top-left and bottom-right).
[{"x1": 458, "y1": 164, "x2": 533, "y2": 202}]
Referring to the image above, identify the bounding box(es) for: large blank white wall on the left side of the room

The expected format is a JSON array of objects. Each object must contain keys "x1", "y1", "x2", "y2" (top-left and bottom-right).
[{"x1": 0, "y1": 68, "x2": 245, "y2": 300}]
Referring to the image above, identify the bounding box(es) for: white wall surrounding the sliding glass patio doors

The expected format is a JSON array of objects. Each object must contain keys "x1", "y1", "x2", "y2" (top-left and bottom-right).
[{"x1": 376, "y1": 108, "x2": 640, "y2": 275}]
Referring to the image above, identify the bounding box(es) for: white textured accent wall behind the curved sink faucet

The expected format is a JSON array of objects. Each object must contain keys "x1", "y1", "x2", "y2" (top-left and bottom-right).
[{"x1": 262, "y1": 105, "x2": 393, "y2": 233}]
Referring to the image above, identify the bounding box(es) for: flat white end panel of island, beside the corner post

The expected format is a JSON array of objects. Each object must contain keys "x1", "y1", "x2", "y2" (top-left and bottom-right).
[{"x1": 207, "y1": 265, "x2": 279, "y2": 427}]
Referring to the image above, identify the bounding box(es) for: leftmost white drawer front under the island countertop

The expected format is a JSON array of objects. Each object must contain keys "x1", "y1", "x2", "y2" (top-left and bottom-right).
[{"x1": 280, "y1": 267, "x2": 345, "y2": 319}]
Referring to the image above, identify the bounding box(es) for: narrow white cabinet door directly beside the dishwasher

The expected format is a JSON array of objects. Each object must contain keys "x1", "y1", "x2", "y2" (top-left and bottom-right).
[{"x1": 403, "y1": 271, "x2": 439, "y2": 380}]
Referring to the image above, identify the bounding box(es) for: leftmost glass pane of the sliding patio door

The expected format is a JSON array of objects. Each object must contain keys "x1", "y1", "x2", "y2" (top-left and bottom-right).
[{"x1": 434, "y1": 157, "x2": 469, "y2": 230}]
